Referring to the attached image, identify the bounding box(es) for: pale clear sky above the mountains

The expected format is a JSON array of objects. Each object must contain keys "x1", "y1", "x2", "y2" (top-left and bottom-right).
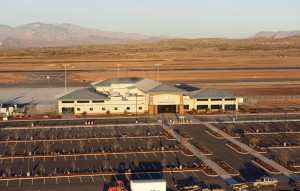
[{"x1": 0, "y1": 0, "x2": 300, "y2": 38}]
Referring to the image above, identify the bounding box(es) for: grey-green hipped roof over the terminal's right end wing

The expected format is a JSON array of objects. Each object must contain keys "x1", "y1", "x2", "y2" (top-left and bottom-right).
[{"x1": 187, "y1": 88, "x2": 235, "y2": 98}]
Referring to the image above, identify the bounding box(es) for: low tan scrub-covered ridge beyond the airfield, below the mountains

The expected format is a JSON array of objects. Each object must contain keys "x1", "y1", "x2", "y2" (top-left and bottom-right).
[{"x1": 0, "y1": 37, "x2": 300, "y2": 59}]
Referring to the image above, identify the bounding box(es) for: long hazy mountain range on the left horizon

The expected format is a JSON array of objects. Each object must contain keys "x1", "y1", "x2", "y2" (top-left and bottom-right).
[{"x1": 0, "y1": 22, "x2": 163, "y2": 47}]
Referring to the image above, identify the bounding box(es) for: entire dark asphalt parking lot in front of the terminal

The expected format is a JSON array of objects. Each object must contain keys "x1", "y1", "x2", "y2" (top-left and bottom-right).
[{"x1": 0, "y1": 115, "x2": 299, "y2": 190}]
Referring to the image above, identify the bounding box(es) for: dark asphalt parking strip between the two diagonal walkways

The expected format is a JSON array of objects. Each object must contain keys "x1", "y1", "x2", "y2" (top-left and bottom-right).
[{"x1": 175, "y1": 124, "x2": 299, "y2": 189}]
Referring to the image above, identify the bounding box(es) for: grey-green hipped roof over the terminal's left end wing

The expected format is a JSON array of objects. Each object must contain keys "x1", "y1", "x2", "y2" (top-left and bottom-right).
[{"x1": 56, "y1": 88, "x2": 109, "y2": 100}]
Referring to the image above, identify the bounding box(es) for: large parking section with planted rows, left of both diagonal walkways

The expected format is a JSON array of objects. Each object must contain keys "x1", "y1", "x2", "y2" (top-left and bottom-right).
[{"x1": 0, "y1": 119, "x2": 228, "y2": 190}]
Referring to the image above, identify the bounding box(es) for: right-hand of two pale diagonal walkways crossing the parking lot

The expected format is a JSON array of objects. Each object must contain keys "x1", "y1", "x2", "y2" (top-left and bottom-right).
[{"x1": 203, "y1": 122, "x2": 299, "y2": 181}]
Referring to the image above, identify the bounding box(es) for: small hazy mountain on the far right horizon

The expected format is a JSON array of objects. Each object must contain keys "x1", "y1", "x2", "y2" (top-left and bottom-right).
[{"x1": 249, "y1": 30, "x2": 300, "y2": 39}]
